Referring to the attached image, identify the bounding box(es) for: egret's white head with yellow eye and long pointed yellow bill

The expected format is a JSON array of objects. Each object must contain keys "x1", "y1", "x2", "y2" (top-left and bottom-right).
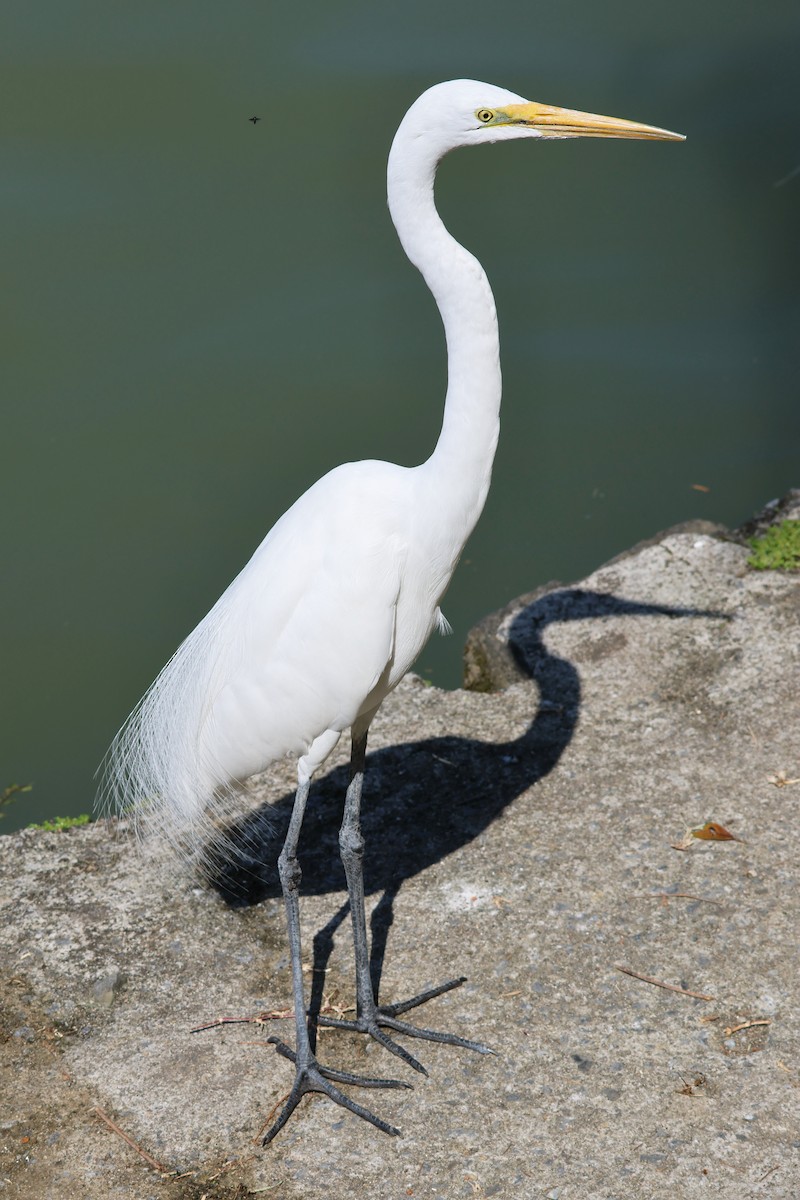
[{"x1": 397, "y1": 79, "x2": 684, "y2": 160}]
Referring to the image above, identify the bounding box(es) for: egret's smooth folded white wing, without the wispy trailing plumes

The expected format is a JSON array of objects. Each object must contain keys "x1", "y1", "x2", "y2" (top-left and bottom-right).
[{"x1": 200, "y1": 463, "x2": 405, "y2": 778}]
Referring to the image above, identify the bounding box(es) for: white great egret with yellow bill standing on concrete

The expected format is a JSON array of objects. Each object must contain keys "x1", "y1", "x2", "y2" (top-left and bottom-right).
[{"x1": 106, "y1": 79, "x2": 681, "y2": 1145}]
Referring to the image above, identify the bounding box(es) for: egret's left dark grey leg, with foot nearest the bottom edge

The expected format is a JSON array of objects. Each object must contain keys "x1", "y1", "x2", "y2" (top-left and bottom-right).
[{"x1": 261, "y1": 780, "x2": 409, "y2": 1146}]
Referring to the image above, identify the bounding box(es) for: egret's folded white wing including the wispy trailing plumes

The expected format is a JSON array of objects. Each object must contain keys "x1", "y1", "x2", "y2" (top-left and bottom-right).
[{"x1": 104, "y1": 463, "x2": 408, "y2": 825}]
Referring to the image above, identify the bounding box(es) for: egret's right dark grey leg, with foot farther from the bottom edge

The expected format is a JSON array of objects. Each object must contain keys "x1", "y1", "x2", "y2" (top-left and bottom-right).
[{"x1": 318, "y1": 733, "x2": 493, "y2": 1075}]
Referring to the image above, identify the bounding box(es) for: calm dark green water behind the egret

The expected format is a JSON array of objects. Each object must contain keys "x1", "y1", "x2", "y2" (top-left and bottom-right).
[{"x1": 0, "y1": 0, "x2": 800, "y2": 830}]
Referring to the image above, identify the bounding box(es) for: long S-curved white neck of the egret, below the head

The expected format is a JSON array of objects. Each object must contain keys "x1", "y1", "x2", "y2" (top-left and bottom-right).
[{"x1": 387, "y1": 137, "x2": 501, "y2": 539}]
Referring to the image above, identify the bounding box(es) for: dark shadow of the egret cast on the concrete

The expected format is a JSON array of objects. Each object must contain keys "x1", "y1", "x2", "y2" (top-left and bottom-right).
[{"x1": 204, "y1": 588, "x2": 729, "y2": 1019}]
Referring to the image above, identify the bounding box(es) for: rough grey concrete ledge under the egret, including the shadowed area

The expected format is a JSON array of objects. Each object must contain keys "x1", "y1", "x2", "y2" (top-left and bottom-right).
[{"x1": 0, "y1": 501, "x2": 800, "y2": 1200}]
